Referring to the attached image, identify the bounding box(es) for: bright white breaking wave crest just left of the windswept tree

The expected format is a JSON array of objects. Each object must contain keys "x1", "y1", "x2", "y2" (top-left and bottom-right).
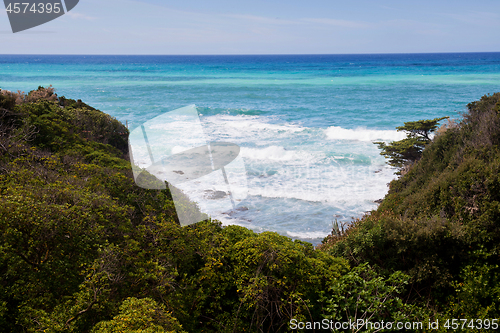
[{"x1": 325, "y1": 126, "x2": 406, "y2": 141}]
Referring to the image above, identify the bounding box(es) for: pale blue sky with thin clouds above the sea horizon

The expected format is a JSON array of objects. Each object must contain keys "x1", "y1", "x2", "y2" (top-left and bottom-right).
[{"x1": 0, "y1": 0, "x2": 500, "y2": 55}]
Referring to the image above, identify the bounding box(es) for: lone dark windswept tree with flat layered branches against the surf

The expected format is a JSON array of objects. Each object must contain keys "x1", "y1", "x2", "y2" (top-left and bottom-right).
[{"x1": 374, "y1": 117, "x2": 449, "y2": 168}]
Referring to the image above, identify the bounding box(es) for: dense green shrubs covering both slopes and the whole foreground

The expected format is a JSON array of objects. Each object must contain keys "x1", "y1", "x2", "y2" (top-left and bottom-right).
[{"x1": 0, "y1": 87, "x2": 500, "y2": 333}]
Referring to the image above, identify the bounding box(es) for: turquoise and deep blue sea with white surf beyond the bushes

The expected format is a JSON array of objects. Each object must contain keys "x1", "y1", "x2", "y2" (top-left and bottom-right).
[{"x1": 0, "y1": 53, "x2": 500, "y2": 244}]
